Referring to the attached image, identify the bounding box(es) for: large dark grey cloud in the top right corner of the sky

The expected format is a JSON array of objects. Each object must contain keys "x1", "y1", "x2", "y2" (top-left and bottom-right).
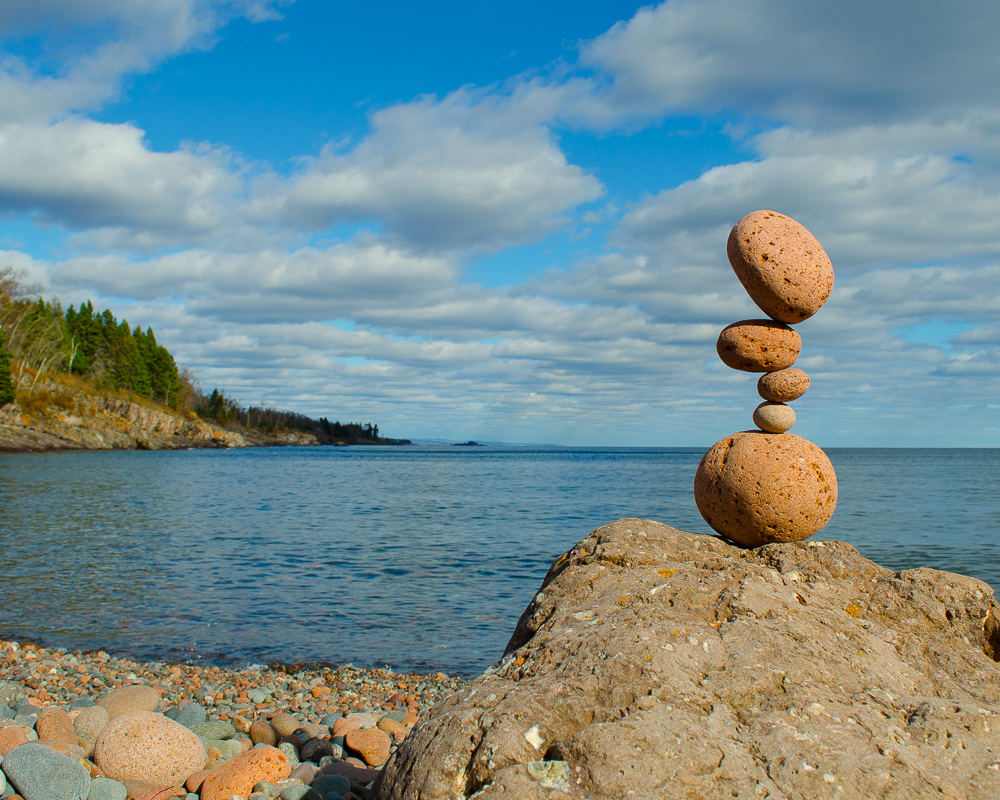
[{"x1": 579, "y1": 0, "x2": 1000, "y2": 128}]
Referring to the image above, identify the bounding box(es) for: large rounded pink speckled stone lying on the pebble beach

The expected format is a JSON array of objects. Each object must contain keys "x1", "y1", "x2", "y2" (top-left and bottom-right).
[{"x1": 94, "y1": 711, "x2": 205, "y2": 786}]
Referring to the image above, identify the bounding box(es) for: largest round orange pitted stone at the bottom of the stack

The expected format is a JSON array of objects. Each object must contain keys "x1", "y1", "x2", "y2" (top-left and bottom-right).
[{"x1": 694, "y1": 431, "x2": 837, "y2": 547}]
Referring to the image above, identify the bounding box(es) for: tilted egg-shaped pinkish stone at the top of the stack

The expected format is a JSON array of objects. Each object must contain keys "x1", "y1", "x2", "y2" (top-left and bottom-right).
[{"x1": 726, "y1": 211, "x2": 833, "y2": 324}]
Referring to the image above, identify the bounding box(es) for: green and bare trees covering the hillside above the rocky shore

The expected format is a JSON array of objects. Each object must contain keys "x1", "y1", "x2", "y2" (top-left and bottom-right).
[{"x1": 0, "y1": 267, "x2": 396, "y2": 443}]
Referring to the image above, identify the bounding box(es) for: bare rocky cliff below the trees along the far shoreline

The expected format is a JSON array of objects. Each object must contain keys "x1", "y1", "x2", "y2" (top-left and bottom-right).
[{"x1": 0, "y1": 382, "x2": 317, "y2": 452}]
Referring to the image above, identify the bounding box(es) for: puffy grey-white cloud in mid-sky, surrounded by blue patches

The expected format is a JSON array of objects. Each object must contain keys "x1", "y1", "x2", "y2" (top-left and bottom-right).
[{"x1": 255, "y1": 90, "x2": 603, "y2": 250}]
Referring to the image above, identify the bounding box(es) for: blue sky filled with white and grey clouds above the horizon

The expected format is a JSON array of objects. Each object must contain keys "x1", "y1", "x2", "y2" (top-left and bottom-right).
[{"x1": 0, "y1": 0, "x2": 1000, "y2": 447}]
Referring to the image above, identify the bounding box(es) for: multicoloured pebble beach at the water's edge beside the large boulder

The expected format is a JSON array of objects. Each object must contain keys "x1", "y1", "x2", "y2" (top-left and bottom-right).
[{"x1": 0, "y1": 641, "x2": 463, "y2": 800}]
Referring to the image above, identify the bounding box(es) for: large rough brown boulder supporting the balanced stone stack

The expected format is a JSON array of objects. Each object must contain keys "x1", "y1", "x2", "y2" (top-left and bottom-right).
[{"x1": 373, "y1": 519, "x2": 1000, "y2": 800}]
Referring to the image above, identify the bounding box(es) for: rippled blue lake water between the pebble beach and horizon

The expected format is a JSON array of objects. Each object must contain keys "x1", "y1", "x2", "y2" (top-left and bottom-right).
[{"x1": 0, "y1": 447, "x2": 1000, "y2": 677}]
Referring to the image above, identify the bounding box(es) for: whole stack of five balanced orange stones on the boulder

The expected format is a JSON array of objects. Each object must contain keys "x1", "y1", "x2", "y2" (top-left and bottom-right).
[{"x1": 694, "y1": 211, "x2": 837, "y2": 547}]
